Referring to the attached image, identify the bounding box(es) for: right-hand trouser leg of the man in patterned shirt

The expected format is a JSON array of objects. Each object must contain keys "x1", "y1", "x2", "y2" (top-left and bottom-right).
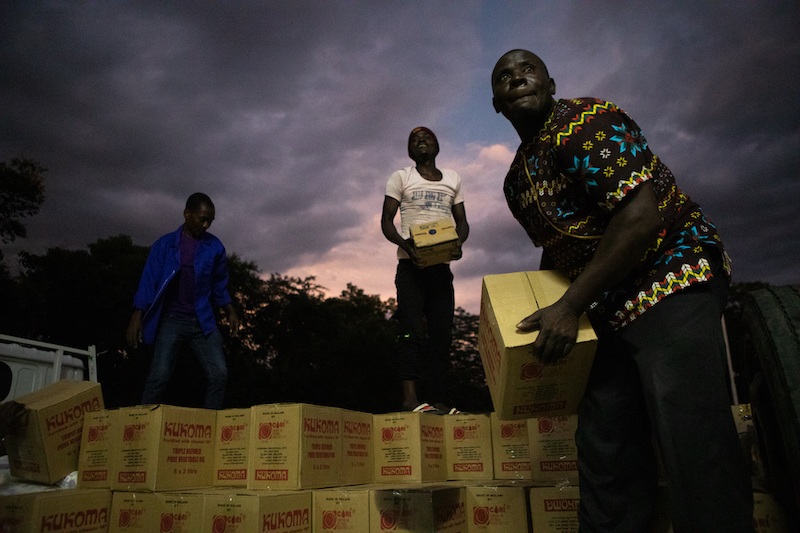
[{"x1": 621, "y1": 286, "x2": 753, "y2": 533}]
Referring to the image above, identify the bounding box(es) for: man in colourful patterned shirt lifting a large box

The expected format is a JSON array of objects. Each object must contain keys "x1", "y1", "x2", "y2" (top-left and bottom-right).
[{"x1": 492, "y1": 50, "x2": 753, "y2": 533}]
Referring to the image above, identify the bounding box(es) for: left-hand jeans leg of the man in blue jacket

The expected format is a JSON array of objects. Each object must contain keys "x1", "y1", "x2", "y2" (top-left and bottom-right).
[{"x1": 142, "y1": 317, "x2": 192, "y2": 405}]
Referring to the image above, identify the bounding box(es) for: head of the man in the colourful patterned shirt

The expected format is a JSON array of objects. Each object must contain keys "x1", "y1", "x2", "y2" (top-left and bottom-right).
[{"x1": 492, "y1": 50, "x2": 556, "y2": 123}]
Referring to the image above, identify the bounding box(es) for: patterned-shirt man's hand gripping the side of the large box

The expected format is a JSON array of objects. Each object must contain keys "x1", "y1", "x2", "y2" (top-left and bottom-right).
[{"x1": 517, "y1": 300, "x2": 580, "y2": 365}]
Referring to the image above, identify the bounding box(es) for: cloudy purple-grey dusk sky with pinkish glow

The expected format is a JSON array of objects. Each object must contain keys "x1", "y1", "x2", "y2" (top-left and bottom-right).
[{"x1": 0, "y1": 0, "x2": 800, "y2": 313}]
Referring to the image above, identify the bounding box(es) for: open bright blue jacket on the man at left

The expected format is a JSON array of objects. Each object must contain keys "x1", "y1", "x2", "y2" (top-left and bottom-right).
[{"x1": 133, "y1": 226, "x2": 231, "y2": 344}]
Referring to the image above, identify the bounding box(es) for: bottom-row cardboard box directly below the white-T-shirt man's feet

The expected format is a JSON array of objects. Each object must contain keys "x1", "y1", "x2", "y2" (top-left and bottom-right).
[{"x1": 369, "y1": 484, "x2": 467, "y2": 533}]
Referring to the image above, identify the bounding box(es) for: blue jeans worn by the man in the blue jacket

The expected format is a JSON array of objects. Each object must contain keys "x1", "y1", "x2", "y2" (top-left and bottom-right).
[{"x1": 142, "y1": 315, "x2": 228, "y2": 409}]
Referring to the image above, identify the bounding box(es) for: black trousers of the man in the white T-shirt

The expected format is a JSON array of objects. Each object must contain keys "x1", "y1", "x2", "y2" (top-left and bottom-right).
[{"x1": 395, "y1": 259, "x2": 455, "y2": 402}]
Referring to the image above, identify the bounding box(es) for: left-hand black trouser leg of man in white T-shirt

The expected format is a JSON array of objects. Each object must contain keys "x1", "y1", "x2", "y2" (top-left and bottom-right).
[{"x1": 395, "y1": 259, "x2": 425, "y2": 410}]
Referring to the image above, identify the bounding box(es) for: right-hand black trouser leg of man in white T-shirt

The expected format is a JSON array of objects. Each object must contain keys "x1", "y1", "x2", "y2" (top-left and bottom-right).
[{"x1": 423, "y1": 264, "x2": 455, "y2": 409}]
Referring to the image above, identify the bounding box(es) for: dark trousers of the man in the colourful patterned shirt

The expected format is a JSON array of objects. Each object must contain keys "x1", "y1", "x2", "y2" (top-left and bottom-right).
[{"x1": 575, "y1": 281, "x2": 753, "y2": 533}]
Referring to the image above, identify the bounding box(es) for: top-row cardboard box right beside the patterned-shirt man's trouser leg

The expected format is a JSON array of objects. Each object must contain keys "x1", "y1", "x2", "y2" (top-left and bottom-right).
[{"x1": 528, "y1": 415, "x2": 578, "y2": 485}]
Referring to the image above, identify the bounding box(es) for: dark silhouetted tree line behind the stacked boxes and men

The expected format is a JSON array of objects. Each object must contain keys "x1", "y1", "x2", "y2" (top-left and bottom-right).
[{"x1": 0, "y1": 235, "x2": 491, "y2": 412}]
